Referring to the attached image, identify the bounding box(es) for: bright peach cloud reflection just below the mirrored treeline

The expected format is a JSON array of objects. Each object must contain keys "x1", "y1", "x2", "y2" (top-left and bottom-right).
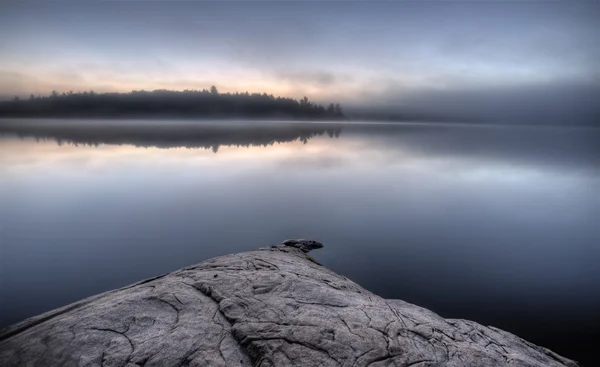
[{"x1": 0, "y1": 129, "x2": 342, "y2": 174}]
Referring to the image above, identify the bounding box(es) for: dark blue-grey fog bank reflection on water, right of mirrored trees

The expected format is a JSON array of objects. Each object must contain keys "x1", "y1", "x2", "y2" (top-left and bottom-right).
[{"x1": 344, "y1": 124, "x2": 600, "y2": 173}]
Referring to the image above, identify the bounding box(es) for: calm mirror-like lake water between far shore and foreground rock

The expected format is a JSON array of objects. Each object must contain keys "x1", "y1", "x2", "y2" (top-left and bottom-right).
[{"x1": 0, "y1": 120, "x2": 600, "y2": 362}]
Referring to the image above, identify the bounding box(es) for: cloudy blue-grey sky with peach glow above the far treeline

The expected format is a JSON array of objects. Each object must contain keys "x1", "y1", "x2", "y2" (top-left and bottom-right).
[{"x1": 0, "y1": 1, "x2": 600, "y2": 122}]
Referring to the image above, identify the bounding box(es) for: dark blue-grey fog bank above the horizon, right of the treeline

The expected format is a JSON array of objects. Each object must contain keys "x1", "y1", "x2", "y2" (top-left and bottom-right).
[{"x1": 355, "y1": 81, "x2": 600, "y2": 125}]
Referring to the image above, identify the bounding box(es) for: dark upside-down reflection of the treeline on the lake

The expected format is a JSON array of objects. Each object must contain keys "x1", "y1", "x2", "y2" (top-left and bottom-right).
[{"x1": 0, "y1": 122, "x2": 343, "y2": 153}]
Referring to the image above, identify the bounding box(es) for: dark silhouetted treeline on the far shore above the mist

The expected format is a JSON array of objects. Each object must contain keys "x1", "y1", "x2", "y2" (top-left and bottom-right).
[{"x1": 0, "y1": 86, "x2": 344, "y2": 120}]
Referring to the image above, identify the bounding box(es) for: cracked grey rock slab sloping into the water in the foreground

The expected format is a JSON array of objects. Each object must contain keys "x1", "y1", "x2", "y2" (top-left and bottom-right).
[{"x1": 0, "y1": 245, "x2": 577, "y2": 367}]
